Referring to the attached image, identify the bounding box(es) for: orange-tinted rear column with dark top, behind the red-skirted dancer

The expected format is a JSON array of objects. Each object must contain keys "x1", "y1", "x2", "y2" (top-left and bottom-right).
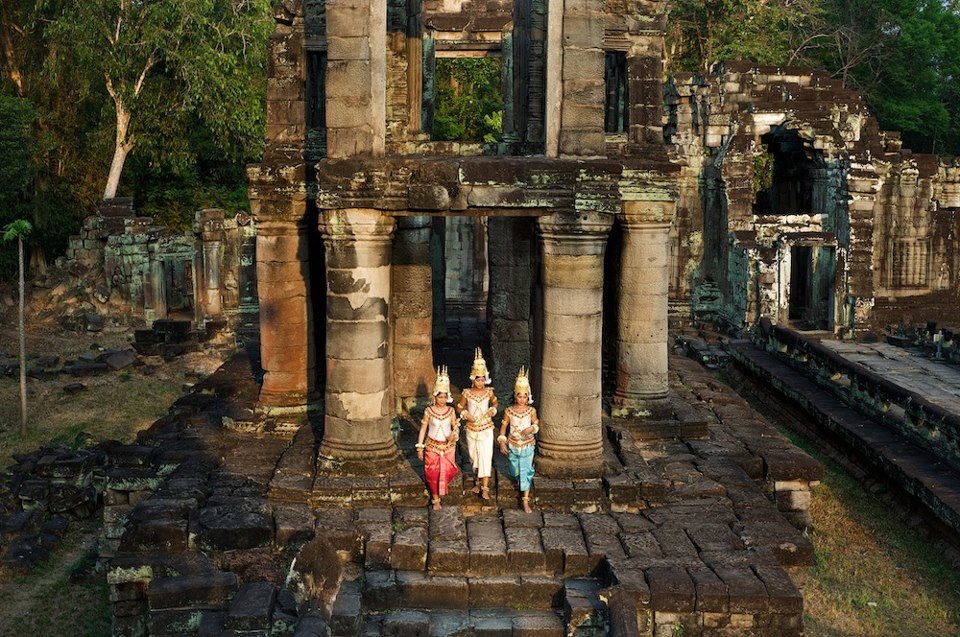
[{"x1": 390, "y1": 216, "x2": 434, "y2": 411}]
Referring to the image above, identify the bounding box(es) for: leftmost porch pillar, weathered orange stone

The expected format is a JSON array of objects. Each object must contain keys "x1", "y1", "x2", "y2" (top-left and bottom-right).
[{"x1": 257, "y1": 221, "x2": 317, "y2": 409}]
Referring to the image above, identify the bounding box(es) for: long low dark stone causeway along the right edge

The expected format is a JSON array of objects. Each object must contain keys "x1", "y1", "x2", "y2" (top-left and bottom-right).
[{"x1": 731, "y1": 332, "x2": 960, "y2": 543}]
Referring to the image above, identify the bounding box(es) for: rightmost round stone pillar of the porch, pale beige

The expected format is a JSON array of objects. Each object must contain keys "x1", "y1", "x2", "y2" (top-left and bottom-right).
[{"x1": 613, "y1": 201, "x2": 674, "y2": 410}]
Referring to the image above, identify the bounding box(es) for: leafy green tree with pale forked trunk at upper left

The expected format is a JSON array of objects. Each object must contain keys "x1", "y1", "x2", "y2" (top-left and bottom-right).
[{"x1": 49, "y1": 0, "x2": 273, "y2": 199}]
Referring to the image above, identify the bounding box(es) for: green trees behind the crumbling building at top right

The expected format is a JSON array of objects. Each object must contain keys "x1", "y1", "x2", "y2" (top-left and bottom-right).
[{"x1": 666, "y1": 0, "x2": 960, "y2": 154}]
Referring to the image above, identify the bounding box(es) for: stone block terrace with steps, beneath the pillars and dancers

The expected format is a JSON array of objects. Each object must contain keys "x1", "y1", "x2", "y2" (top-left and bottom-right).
[{"x1": 103, "y1": 356, "x2": 821, "y2": 637}]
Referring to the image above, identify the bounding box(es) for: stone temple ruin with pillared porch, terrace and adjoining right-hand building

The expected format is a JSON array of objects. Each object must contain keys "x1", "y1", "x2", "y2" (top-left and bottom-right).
[{"x1": 3, "y1": 0, "x2": 960, "y2": 637}]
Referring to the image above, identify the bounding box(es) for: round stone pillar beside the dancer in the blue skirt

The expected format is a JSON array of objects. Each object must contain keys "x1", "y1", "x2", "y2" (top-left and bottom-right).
[{"x1": 536, "y1": 213, "x2": 613, "y2": 478}]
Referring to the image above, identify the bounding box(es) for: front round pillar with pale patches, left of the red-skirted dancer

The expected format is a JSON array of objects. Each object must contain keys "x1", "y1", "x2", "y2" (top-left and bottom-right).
[{"x1": 320, "y1": 209, "x2": 398, "y2": 474}]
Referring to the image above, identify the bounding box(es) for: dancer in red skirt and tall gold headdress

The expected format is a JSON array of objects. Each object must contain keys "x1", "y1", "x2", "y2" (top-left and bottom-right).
[{"x1": 417, "y1": 367, "x2": 460, "y2": 511}]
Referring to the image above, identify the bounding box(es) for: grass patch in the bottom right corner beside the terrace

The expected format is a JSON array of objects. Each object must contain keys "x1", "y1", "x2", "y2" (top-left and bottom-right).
[{"x1": 804, "y1": 448, "x2": 960, "y2": 637}]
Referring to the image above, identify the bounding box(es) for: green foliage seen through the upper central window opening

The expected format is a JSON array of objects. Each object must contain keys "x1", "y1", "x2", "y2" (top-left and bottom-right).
[{"x1": 433, "y1": 58, "x2": 503, "y2": 142}]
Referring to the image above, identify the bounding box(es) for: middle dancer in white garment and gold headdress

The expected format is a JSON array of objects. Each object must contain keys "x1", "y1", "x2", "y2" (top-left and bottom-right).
[{"x1": 457, "y1": 347, "x2": 497, "y2": 500}]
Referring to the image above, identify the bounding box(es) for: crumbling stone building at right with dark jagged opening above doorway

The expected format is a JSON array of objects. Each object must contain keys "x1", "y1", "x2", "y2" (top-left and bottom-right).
[{"x1": 664, "y1": 62, "x2": 960, "y2": 334}]
